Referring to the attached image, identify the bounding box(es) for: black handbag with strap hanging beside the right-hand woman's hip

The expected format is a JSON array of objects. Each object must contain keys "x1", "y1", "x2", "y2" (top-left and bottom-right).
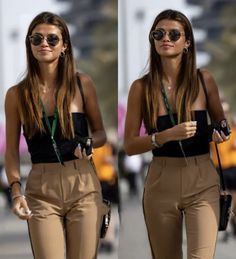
[{"x1": 215, "y1": 143, "x2": 232, "y2": 231}]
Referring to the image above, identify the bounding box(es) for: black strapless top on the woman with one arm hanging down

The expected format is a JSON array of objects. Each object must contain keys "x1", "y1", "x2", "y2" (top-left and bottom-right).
[{"x1": 23, "y1": 112, "x2": 88, "y2": 164}]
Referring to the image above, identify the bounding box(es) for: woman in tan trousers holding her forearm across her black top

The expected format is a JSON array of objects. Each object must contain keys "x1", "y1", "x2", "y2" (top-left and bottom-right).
[{"x1": 124, "y1": 10, "x2": 228, "y2": 259}]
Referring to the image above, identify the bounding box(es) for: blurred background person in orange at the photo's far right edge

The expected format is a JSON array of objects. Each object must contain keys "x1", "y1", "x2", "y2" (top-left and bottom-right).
[{"x1": 211, "y1": 101, "x2": 236, "y2": 241}]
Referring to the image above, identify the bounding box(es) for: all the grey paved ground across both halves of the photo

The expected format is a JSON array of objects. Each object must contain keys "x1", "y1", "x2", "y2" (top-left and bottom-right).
[{"x1": 0, "y1": 182, "x2": 236, "y2": 259}]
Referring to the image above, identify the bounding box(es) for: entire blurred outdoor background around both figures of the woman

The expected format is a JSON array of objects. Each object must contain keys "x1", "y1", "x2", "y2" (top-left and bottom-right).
[{"x1": 0, "y1": 0, "x2": 236, "y2": 259}]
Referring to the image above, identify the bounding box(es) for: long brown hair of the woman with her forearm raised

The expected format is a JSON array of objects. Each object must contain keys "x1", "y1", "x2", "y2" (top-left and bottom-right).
[{"x1": 142, "y1": 10, "x2": 199, "y2": 133}]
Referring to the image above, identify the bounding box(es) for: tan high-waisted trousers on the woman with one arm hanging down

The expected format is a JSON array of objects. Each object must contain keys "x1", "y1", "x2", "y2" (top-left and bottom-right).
[{"x1": 26, "y1": 159, "x2": 106, "y2": 259}]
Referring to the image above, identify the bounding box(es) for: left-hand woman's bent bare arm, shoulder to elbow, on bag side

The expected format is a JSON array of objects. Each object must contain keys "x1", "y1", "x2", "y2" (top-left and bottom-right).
[{"x1": 80, "y1": 74, "x2": 106, "y2": 148}]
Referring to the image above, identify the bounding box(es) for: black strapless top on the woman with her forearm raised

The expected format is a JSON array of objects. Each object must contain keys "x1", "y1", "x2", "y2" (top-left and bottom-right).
[{"x1": 152, "y1": 110, "x2": 209, "y2": 157}]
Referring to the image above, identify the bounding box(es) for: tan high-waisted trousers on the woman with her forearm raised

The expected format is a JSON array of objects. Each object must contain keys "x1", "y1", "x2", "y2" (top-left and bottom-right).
[{"x1": 143, "y1": 154, "x2": 220, "y2": 259}]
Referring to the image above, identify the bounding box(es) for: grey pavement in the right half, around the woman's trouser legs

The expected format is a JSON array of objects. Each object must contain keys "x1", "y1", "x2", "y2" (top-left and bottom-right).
[{"x1": 118, "y1": 181, "x2": 236, "y2": 259}]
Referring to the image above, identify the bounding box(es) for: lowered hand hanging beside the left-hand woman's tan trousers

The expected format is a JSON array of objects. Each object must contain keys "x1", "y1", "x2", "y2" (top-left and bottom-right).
[{"x1": 12, "y1": 195, "x2": 33, "y2": 220}]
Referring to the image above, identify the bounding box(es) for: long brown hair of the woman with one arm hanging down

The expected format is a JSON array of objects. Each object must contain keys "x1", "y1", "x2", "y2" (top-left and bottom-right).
[{"x1": 18, "y1": 12, "x2": 76, "y2": 138}]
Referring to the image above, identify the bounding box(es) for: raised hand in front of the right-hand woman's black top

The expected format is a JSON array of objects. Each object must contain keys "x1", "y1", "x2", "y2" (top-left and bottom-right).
[{"x1": 171, "y1": 121, "x2": 197, "y2": 140}]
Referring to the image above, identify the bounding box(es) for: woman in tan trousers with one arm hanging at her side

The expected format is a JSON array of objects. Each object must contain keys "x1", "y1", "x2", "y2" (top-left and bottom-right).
[{"x1": 5, "y1": 12, "x2": 106, "y2": 259}]
